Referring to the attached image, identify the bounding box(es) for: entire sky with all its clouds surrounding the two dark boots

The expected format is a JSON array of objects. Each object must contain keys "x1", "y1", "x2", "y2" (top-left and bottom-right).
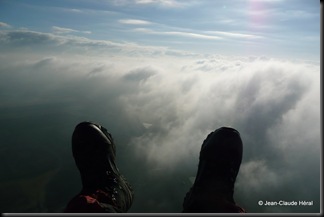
[{"x1": 0, "y1": 0, "x2": 322, "y2": 213}]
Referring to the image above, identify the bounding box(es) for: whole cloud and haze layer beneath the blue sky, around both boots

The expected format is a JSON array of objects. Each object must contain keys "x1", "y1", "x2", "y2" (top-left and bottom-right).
[{"x1": 0, "y1": 31, "x2": 321, "y2": 213}]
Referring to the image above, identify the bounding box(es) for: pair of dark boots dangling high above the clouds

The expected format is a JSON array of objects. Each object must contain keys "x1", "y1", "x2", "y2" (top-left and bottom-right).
[{"x1": 64, "y1": 122, "x2": 244, "y2": 213}]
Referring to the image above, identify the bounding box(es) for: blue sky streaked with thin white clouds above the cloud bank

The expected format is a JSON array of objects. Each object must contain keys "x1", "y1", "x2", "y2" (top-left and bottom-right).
[{"x1": 0, "y1": 0, "x2": 320, "y2": 61}]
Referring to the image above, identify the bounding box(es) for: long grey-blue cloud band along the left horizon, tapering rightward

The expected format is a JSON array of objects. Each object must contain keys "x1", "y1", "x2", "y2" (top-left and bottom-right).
[{"x1": 0, "y1": 30, "x2": 173, "y2": 56}]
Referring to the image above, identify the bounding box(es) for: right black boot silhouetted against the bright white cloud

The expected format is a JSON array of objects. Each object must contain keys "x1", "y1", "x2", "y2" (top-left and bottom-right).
[{"x1": 183, "y1": 127, "x2": 244, "y2": 213}]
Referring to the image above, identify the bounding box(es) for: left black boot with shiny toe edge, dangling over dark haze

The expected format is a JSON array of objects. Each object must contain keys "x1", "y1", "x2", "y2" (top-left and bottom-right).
[{"x1": 70, "y1": 122, "x2": 134, "y2": 212}]
